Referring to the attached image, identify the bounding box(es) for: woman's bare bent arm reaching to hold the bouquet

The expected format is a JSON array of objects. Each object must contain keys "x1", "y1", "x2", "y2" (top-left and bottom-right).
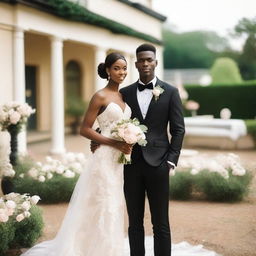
[{"x1": 80, "y1": 94, "x2": 131, "y2": 154}]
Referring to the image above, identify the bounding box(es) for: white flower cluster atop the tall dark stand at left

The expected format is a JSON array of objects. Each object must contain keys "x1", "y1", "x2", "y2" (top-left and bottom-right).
[{"x1": 0, "y1": 102, "x2": 36, "y2": 131}]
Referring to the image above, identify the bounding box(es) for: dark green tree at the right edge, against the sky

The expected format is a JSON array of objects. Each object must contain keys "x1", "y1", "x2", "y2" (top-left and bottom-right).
[{"x1": 234, "y1": 16, "x2": 256, "y2": 80}]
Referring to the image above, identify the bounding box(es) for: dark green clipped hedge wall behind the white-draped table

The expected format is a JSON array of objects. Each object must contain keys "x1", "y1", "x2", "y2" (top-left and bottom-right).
[{"x1": 185, "y1": 81, "x2": 256, "y2": 119}]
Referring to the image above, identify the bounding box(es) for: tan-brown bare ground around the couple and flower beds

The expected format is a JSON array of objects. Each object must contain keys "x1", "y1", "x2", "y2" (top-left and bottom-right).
[{"x1": 11, "y1": 136, "x2": 256, "y2": 256}]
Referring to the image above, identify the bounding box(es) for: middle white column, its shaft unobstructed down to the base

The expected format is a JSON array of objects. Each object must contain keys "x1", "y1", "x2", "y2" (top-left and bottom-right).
[{"x1": 50, "y1": 37, "x2": 65, "y2": 154}]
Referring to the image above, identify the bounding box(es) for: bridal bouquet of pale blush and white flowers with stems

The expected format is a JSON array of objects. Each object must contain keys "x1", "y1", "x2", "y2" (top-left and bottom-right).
[{"x1": 111, "y1": 118, "x2": 148, "y2": 164}]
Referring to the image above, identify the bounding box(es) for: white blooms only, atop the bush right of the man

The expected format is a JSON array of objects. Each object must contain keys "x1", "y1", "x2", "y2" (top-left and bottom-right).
[{"x1": 179, "y1": 153, "x2": 246, "y2": 179}]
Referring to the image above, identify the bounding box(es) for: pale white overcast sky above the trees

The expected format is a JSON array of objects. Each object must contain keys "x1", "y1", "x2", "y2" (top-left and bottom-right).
[{"x1": 153, "y1": 0, "x2": 256, "y2": 50}]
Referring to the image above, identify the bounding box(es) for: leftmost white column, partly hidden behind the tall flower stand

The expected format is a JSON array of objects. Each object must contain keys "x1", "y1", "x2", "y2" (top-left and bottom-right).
[{"x1": 13, "y1": 27, "x2": 27, "y2": 153}]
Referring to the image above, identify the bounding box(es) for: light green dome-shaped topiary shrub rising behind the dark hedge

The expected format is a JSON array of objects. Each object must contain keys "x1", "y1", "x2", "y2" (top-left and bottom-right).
[{"x1": 210, "y1": 57, "x2": 242, "y2": 84}]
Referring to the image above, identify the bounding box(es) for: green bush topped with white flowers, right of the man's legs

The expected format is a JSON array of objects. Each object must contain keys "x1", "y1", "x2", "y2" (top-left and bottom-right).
[{"x1": 170, "y1": 153, "x2": 252, "y2": 202}]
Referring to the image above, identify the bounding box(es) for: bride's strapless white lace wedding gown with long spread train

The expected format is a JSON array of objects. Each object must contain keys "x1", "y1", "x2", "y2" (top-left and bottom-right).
[{"x1": 22, "y1": 102, "x2": 220, "y2": 256}]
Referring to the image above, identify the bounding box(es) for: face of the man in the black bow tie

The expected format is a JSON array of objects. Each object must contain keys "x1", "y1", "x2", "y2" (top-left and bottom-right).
[{"x1": 135, "y1": 51, "x2": 157, "y2": 82}]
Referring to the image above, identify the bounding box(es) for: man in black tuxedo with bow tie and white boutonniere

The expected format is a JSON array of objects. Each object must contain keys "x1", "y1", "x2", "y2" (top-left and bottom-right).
[{"x1": 120, "y1": 44, "x2": 185, "y2": 256}]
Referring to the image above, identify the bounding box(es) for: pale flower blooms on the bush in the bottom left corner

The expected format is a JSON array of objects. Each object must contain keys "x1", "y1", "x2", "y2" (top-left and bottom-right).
[{"x1": 0, "y1": 192, "x2": 40, "y2": 223}]
